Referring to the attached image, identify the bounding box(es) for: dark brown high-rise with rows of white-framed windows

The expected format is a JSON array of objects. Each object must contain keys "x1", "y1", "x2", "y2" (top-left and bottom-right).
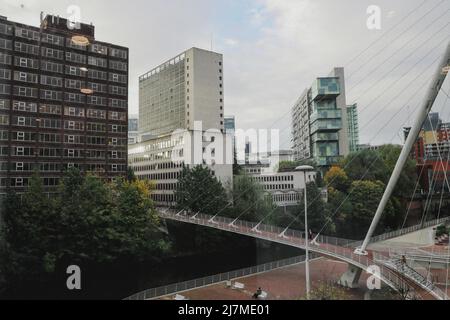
[{"x1": 0, "y1": 15, "x2": 128, "y2": 198}]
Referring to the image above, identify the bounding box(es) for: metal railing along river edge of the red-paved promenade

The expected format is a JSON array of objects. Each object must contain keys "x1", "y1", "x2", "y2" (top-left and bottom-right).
[{"x1": 124, "y1": 255, "x2": 316, "y2": 300}]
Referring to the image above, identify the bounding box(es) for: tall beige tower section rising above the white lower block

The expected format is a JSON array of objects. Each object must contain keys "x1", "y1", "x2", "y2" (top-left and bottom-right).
[{"x1": 139, "y1": 48, "x2": 224, "y2": 137}]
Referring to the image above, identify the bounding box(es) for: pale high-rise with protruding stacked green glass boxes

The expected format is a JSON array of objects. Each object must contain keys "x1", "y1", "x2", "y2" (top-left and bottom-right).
[{"x1": 292, "y1": 68, "x2": 349, "y2": 168}]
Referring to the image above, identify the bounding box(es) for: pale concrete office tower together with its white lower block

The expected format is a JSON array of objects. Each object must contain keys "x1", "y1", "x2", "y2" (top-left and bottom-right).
[{"x1": 129, "y1": 48, "x2": 233, "y2": 206}]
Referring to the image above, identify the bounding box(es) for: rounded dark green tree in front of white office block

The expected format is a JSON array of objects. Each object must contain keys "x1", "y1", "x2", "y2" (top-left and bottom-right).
[{"x1": 176, "y1": 166, "x2": 228, "y2": 215}]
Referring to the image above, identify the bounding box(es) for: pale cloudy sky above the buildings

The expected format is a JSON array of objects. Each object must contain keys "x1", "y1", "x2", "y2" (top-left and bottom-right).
[{"x1": 0, "y1": 0, "x2": 450, "y2": 148}]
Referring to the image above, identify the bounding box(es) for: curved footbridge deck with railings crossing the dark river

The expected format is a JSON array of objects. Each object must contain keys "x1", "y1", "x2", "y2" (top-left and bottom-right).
[{"x1": 158, "y1": 209, "x2": 448, "y2": 300}]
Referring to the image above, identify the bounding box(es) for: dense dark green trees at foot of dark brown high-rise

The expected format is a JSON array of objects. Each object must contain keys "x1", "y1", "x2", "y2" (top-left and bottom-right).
[{"x1": 2, "y1": 169, "x2": 169, "y2": 292}]
